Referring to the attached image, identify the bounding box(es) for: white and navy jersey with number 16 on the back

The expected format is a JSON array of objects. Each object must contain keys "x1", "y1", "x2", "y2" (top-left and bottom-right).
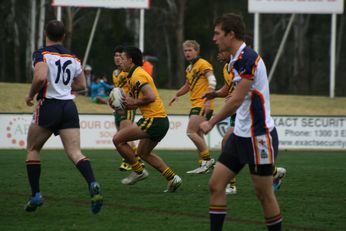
[{"x1": 33, "y1": 44, "x2": 82, "y2": 100}]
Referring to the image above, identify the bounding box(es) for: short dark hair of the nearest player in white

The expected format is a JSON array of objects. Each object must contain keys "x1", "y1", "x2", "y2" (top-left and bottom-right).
[{"x1": 214, "y1": 13, "x2": 245, "y2": 40}]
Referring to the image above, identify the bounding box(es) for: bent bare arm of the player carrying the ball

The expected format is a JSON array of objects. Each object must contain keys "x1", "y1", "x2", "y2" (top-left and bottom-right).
[{"x1": 124, "y1": 84, "x2": 156, "y2": 110}]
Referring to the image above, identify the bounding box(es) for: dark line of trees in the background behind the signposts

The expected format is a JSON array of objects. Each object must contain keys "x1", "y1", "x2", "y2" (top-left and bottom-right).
[{"x1": 0, "y1": 0, "x2": 346, "y2": 96}]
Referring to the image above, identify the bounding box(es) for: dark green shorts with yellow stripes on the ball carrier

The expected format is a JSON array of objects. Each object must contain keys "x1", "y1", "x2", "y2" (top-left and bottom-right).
[{"x1": 137, "y1": 117, "x2": 169, "y2": 142}]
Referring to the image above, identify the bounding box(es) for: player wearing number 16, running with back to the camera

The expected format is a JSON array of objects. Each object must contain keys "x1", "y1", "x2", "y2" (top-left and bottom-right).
[{"x1": 24, "y1": 20, "x2": 103, "y2": 213}]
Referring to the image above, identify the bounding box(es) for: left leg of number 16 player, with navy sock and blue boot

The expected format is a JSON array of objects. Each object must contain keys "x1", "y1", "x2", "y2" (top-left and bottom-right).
[{"x1": 24, "y1": 123, "x2": 52, "y2": 212}]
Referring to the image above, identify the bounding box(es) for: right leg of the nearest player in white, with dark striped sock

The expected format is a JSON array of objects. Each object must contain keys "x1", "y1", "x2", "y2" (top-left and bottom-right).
[{"x1": 251, "y1": 169, "x2": 282, "y2": 231}]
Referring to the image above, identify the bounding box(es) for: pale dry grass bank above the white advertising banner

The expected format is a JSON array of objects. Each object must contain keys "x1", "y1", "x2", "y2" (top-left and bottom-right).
[{"x1": 0, "y1": 82, "x2": 346, "y2": 116}]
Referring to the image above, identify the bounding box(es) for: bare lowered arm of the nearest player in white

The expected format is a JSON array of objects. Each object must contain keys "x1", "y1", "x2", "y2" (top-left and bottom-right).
[{"x1": 200, "y1": 78, "x2": 253, "y2": 133}]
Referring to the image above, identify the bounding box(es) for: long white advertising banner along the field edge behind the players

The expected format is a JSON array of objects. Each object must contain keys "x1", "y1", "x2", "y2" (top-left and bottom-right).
[{"x1": 0, "y1": 114, "x2": 346, "y2": 150}]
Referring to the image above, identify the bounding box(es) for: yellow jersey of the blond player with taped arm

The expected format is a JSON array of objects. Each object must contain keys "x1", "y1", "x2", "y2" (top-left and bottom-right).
[{"x1": 185, "y1": 58, "x2": 214, "y2": 109}]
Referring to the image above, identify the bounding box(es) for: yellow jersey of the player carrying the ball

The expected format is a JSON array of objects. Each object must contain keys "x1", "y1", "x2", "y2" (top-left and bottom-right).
[{"x1": 127, "y1": 66, "x2": 167, "y2": 118}]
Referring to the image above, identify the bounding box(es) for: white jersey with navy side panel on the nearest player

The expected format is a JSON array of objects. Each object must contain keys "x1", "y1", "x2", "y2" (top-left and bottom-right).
[{"x1": 229, "y1": 43, "x2": 274, "y2": 138}]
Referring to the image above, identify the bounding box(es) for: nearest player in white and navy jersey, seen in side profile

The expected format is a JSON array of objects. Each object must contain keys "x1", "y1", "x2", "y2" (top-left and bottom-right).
[{"x1": 200, "y1": 13, "x2": 282, "y2": 231}]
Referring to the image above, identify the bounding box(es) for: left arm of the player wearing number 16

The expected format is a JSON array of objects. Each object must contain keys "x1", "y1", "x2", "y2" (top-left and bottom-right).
[{"x1": 25, "y1": 62, "x2": 48, "y2": 106}]
